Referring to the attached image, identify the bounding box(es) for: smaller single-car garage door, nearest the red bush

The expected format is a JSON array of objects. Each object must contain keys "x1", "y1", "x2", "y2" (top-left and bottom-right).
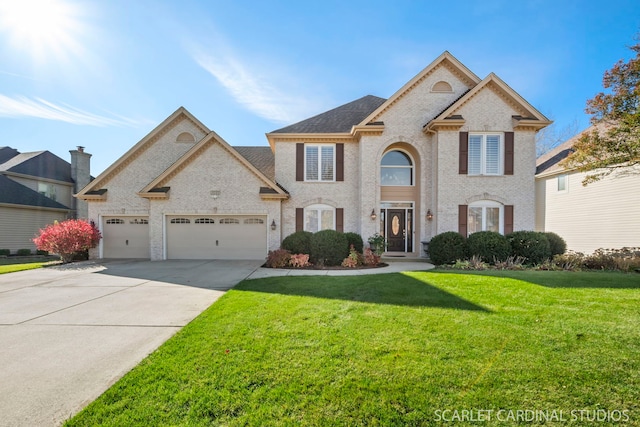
[{"x1": 102, "y1": 216, "x2": 149, "y2": 258}]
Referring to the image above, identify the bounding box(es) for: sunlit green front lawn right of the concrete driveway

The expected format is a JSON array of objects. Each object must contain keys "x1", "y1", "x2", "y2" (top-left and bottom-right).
[{"x1": 68, "y1": 271, "x2": 640, "y2": 426}]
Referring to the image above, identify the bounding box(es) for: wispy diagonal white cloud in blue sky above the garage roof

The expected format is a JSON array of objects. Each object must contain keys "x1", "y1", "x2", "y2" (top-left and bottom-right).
[{"x1": 193, "y1": 52, "x2": 318, "y2": 124}]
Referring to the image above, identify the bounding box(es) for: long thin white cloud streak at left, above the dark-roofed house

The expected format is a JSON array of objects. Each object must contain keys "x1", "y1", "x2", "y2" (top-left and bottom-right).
[{"x1": 0, "y1": 94, "x2": 138, "y2": 127}]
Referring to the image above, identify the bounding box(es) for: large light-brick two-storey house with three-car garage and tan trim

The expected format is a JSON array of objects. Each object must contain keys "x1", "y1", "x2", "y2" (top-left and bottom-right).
[{"x1": 78, "y1": 52, "x2": 550, "y2": 260}]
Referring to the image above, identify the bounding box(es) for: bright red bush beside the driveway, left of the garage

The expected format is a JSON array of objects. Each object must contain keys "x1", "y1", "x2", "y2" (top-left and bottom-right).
[{"x1": 33, "y1": 219, "x2": 102, "y2": 263}]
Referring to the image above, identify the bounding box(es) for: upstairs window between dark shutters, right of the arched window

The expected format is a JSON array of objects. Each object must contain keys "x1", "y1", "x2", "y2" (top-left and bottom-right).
[{"x1": 468, "y1": 133, "x2": 504, "y2": 175}]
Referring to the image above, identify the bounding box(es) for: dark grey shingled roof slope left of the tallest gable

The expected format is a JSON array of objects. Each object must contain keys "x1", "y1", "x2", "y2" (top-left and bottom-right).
[{"x1": 271, "y1": 95, "x2": 386, "y2": 133}]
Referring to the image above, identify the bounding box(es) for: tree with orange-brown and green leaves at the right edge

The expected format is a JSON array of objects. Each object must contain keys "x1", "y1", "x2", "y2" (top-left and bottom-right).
[{"x1": 561, "y1": 35, "x2": 640, "y2": 185}]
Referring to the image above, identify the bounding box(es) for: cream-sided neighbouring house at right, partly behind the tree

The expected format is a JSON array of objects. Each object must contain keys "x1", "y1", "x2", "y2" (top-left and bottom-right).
[{"x1": 536, "y1": 127, "x2": 640, "y2": 254}]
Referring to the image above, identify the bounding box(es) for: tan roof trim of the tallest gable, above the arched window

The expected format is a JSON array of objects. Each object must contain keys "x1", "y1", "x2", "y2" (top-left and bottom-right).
[{"x1": 359, "y1": 50, "x2": 480, "y2": 125}]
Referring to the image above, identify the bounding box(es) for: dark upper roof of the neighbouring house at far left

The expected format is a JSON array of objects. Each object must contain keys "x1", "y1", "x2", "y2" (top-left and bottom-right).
[{"x1": 0, "y1": 151, "x2": 73, "y2": 182}]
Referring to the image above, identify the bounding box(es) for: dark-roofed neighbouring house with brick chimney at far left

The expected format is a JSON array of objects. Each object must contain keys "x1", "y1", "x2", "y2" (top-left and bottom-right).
[{"x1": 0, "y1": 147, "x2": 91, "y2": 253}]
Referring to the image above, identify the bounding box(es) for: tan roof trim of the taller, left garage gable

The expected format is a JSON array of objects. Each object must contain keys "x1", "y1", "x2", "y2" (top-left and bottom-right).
[{"x1": 76, "y1": 107, "x2": 210, "y2": 198}]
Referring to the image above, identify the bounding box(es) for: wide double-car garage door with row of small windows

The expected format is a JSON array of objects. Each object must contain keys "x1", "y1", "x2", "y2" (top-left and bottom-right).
[{"x1": 166, "y1": 215, "x2": 267, "y2": 259}]
